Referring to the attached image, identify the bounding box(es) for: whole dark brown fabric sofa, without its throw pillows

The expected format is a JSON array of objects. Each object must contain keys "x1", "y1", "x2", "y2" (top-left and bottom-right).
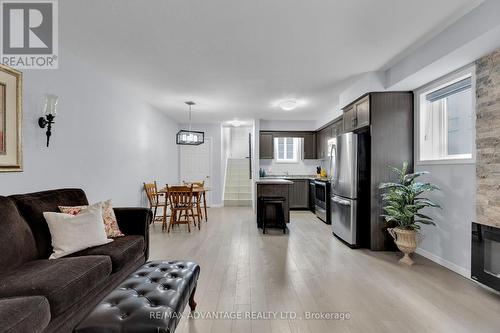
[{"x1": 0, "y1": 189, "x2": 152, "y2": 332}]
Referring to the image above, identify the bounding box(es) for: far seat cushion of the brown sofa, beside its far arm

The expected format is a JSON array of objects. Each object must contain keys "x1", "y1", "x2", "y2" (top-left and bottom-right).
[{"x1": 70, "y1": 235, "x2": 145, "y2": 272}]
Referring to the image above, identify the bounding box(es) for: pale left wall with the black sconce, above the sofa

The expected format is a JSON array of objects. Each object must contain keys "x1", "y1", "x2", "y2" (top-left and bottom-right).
[{"x1": 0, "y1": 49, "x2": 179, "y2": 206}]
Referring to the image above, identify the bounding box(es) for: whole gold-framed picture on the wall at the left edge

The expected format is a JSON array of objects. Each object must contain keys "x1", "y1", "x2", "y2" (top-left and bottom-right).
[{"x1": 0, "y1": 65, "x2": 23, "y2": 172}]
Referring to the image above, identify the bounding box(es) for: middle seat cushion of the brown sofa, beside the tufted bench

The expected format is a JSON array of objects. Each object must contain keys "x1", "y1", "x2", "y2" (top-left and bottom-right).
[{"x1": 0, "y1": 256, "x2": 111, "y2": 317}]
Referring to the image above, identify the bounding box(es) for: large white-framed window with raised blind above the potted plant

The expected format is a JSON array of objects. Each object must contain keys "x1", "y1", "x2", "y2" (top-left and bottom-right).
[{"x1": 416, "y1": 69, "x2": 475, "y2": 162}]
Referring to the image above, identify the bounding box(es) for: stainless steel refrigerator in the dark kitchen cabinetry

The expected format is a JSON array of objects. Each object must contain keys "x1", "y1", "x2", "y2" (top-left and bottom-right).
[{"x1": 330, "y1": 132, "x2": 369, "y2": 247}]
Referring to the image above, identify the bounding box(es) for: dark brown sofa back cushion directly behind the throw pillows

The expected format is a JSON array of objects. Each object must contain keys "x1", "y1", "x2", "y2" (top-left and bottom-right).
[{"x1": 9, "y1": 189, "x2": 89, "y2": 259}]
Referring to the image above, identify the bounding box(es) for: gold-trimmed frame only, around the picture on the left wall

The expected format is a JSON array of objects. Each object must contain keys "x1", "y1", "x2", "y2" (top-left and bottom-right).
[{"x1": 0, "y1": 64, "x2": 23, "y2": 172}]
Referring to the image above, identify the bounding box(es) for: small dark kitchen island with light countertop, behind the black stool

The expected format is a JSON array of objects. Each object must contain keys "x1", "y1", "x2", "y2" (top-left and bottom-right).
[{"x1": 255, "y1": 178, "x2": 293, "y2": 227}]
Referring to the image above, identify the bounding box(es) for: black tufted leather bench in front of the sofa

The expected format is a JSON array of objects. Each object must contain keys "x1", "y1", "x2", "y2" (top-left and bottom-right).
[{"x1": 75, "y1": 260, "x2": 200, "y2": 333}]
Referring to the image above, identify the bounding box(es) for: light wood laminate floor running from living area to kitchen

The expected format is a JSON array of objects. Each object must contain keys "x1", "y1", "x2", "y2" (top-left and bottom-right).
[{"x1": 150, "y1": 207, "x2": 500, "y2": 333}]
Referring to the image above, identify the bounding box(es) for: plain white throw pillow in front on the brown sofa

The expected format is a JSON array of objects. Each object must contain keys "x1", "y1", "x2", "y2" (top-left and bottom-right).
[{"x1": 43, "y1": 203, "x2": 113, "y2": 259}]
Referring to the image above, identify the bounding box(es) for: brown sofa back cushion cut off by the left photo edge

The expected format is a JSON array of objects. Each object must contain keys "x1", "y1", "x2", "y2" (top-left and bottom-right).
[{"x1": 0, "y1": 196, "x2": 37, "y2": 273}]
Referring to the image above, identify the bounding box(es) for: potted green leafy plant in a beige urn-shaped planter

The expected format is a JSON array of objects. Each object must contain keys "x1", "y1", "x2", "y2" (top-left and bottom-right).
[{"x1": 379, "y1": 162, "x2": 441, "y2": 266}]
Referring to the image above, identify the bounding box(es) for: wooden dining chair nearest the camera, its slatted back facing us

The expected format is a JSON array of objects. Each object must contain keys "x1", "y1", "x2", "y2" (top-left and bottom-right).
[{"x1": 162, "y1": 184, "x2": 201, "y2": 232}]
